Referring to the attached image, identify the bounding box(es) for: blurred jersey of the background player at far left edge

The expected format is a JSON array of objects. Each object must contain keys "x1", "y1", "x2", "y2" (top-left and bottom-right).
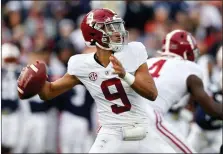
[{"x1": 1, "y1": 66, "x2": 21, "y2": 114}]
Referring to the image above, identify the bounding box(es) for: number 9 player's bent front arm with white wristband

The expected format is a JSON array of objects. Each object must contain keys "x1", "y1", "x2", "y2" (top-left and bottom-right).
[{"x1": 110, "y1": 55, "x2": 158, "y2": 101}]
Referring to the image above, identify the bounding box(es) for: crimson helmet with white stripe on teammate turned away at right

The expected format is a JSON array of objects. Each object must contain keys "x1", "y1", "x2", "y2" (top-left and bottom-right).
[{"x1": 161, "y1": 30, "x2": 199, "y2": 61}]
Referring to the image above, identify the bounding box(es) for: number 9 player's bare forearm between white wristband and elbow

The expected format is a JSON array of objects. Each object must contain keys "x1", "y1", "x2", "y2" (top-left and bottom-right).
[{"x1": 131, "y1": 78, "x2": 158, "y2": 101}]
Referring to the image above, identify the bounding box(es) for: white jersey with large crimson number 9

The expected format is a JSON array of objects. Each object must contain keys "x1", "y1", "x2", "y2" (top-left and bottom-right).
[{"x1": 67, "y1": 42, "x2": 152, "y2": 127}]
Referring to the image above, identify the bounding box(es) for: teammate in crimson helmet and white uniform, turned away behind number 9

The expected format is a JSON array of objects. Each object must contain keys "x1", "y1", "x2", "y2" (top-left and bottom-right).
[{"x1": 147, "y1": 30, "x2": 223, "y2": 152}]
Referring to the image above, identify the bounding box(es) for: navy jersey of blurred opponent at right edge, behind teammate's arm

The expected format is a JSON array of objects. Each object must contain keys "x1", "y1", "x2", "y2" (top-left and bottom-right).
[{"x1": 195, "y1": 91, "x2": 223, "y2": 130}]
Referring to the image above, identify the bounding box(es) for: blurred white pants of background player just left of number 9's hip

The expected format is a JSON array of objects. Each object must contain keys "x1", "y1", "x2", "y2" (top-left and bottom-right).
[{"x1": 59, "y1": 111, "x2": 90, "y2": 153}]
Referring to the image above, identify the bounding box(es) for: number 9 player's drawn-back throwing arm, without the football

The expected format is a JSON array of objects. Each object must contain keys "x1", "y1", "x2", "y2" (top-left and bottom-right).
[{"x1": 39, "y1": 73, "x2": 81, "y2": 100}]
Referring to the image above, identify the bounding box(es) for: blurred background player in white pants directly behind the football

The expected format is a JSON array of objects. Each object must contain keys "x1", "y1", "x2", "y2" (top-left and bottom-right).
[{"x1": 15, "y1": 43, "x2": 53, "y2": 153}]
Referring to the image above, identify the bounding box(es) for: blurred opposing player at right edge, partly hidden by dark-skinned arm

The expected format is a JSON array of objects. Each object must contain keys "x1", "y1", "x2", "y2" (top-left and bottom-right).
[{"x1": 188, "y1": 47, "x2": 223, "y2": 153}]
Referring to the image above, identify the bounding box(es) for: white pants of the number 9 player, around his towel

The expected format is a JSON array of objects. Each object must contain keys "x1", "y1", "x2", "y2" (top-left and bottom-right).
[{"x1": 89, "y1": 126, "x2": 176, "y2": 153}]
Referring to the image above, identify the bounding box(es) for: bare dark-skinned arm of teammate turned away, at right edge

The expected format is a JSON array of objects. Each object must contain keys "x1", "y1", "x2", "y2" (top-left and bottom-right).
[{"x1": 187, "y1": 75, "x2": 223, "y2": 119}]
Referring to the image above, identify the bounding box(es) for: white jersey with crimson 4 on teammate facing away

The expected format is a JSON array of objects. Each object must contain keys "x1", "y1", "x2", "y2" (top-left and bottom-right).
[{"x1": 147, "y1": 57, "x2": 203, "y2": 113}]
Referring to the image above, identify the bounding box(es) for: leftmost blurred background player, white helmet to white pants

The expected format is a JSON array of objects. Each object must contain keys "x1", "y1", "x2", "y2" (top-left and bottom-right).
[{"x1": 1, "y1": 43, "x2": 24, "y2": 153}]
